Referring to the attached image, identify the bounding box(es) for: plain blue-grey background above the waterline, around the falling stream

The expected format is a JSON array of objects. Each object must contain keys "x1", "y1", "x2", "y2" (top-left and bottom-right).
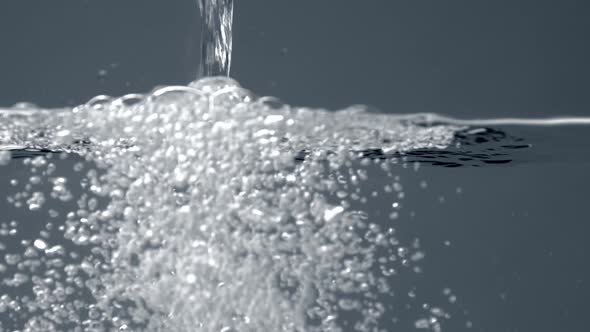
[{"x1": 0, "y1": 0, "x2": 590, "y2": 117}]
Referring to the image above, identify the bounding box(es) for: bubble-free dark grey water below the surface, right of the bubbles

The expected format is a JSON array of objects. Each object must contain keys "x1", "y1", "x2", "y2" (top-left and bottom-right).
[{"x1": 384, "y1": 128, "x2": 590, "y2": 331}]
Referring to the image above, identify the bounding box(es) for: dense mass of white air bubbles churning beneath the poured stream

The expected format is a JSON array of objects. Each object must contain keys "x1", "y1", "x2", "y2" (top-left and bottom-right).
[{"x1": 0, "y1": 78, "x2": 458, "y2": 332}]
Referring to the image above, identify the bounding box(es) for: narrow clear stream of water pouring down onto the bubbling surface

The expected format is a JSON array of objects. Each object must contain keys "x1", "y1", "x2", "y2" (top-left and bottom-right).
[{"x1": 197, "y1": 0, "x2": 234, "y2": 77}]
